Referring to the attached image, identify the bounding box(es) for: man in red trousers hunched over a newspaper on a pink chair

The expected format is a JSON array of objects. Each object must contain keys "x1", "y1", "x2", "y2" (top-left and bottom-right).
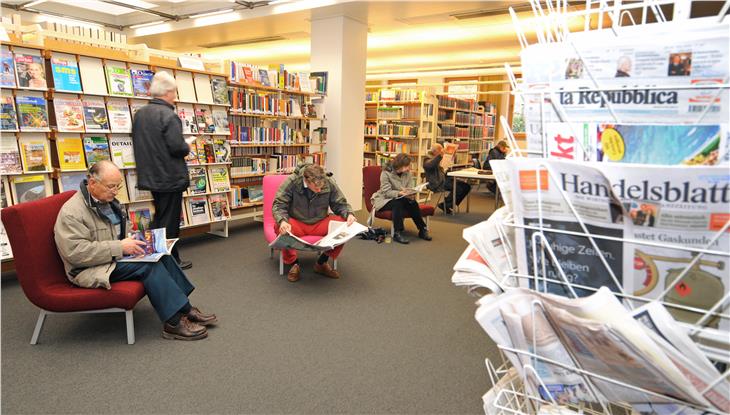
[{"x1": 272, "y1": 164, "x2": 357, "y2": 282}]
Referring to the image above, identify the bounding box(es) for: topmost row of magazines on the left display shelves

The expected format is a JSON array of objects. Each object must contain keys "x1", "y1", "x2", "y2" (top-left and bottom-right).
[{"x1": 0, "y1": 45, "x2": 230, "y2": 106}]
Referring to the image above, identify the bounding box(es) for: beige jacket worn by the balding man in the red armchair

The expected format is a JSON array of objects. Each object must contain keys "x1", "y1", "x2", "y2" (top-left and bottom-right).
[{"x1": 53, "y1": 185, "x2": 127, "y2": 290}]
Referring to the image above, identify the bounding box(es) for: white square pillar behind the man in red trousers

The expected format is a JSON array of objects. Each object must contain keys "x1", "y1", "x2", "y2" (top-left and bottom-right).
[{"x1": 311, "y1": 15, "x2": 367, "y2": 210}]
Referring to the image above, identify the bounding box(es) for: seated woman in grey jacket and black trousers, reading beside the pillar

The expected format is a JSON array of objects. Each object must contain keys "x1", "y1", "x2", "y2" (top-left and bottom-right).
[{"x1": 372, "y1": 154, "x2": 431, "y2": 244}]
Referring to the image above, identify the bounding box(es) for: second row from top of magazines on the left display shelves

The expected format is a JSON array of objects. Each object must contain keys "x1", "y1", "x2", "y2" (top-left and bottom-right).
[{"x1": 0, "y1": 91, "x2": 230, "y2": 135}]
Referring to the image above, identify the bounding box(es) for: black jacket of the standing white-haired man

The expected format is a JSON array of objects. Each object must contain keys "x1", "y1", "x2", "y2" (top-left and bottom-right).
[{"x1": 132, "y1": 98, "x2": 190, "y2": 192}]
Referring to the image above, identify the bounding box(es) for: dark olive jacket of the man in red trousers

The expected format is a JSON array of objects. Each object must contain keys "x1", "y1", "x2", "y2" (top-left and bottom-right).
[{"x1": 272, "y1": 164, "x2": 353, "y2": 225}]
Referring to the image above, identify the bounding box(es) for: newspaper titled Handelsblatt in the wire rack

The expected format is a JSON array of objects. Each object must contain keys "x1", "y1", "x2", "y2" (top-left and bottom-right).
[{"x1": 507, "y1": 158, "x2": 730, "y2": 328}]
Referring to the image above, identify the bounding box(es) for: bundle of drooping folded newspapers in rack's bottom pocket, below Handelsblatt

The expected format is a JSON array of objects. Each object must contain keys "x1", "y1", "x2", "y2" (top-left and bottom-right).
[{"x1": 476, "y1": 287, "x2": 730, "y2": 413}]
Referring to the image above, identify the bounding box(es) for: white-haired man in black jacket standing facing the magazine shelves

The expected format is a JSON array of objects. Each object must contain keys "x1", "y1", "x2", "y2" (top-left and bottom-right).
[{"x1": 132, "y1": 72, "x2": 193, "y2": 269}]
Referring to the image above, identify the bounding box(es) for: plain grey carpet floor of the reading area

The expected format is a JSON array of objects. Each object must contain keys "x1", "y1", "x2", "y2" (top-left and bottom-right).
[{"x1": 1, "y1": 194, "x2": 497, "y2": 414}]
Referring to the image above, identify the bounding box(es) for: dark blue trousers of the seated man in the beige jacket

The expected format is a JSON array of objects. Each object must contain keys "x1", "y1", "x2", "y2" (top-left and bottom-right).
[{"x1": 109, "y1": 255, "x2": 195, "y2": 323}]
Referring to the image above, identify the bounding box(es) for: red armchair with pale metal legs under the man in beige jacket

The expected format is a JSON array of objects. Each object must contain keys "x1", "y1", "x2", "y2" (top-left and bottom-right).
[{"x1": 2, "y1": 191, "x2": 145, "y2": 344}]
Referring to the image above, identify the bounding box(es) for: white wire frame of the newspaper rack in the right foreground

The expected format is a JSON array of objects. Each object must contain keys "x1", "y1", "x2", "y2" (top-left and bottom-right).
[{"x1": 470, "y1": 0, "x2": 730, "y2": 414}]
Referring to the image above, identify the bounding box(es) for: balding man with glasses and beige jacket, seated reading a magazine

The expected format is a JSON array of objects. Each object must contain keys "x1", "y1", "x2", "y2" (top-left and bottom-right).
[{"x1": 53, "y1": 161, "x2": 217, "y2": 340}]
